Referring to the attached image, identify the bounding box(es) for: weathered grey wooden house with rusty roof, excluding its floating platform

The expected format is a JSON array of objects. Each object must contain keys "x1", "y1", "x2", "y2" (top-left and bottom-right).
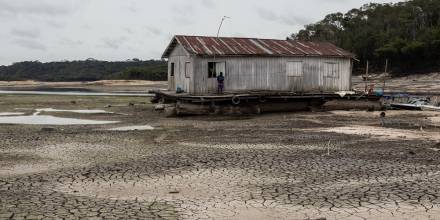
[{"x1": 162, "y1": 35, "x2": 354, "y2": 95}]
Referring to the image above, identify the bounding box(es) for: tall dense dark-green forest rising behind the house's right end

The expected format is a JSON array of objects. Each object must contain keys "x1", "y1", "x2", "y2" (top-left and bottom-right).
[{"x1": 291, "y1": 0, "x2": 440, "y2": 74}]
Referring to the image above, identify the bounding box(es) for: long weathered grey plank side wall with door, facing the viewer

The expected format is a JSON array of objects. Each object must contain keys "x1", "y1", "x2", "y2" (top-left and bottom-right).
[{"x1": 191, "y1": 57, "x2": 351, "y2": 95}]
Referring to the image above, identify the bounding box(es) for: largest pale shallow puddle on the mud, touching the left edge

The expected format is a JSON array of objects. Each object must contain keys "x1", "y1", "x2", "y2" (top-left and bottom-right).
[{"x1": 0, "y1": 114, "x2": 119, "y2": 125}]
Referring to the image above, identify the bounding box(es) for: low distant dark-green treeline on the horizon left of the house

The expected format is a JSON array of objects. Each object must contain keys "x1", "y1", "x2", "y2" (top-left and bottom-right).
[{"x1": 0, "y1": 59, "x2": 167, "y2": 81}]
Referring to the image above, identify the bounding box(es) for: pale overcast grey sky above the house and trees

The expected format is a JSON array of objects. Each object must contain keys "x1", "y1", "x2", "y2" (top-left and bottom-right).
[{"x1": 0, "y1": 0, "x2": 398, "y2": 65}]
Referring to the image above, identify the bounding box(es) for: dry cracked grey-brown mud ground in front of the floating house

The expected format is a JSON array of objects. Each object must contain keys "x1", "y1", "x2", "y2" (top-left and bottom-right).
[{"x1": 0, "y1": 95, "x2": 440, "y2": 219}]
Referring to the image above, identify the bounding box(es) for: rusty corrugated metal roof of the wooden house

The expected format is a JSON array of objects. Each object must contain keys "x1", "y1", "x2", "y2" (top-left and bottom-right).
[{"x1": 162, "y1": 35, "x2": 355, "y2": 58}]
